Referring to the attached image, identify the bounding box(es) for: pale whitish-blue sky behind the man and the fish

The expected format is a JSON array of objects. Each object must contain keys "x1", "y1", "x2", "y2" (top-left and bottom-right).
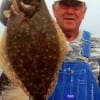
[{"x1": 0, "y1": 0, "x2": 100, "y2": 37}]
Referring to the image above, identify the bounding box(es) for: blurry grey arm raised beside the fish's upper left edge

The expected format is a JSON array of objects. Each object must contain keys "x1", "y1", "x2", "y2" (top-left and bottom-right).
[{"x1": 0, "y1": 0, "x2": 12, "y2": 25}]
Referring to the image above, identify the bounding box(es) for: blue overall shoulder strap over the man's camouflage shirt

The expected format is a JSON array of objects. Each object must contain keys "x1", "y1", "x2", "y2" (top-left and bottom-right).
[{"x1": 82, "y1": 31, "x2": 91, "y2": 58}]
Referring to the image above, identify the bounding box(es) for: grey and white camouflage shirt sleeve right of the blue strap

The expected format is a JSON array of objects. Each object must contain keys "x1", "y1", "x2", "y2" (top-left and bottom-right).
[{"x1": 90, "y1": 36, "x2": 100, "y2": 80}]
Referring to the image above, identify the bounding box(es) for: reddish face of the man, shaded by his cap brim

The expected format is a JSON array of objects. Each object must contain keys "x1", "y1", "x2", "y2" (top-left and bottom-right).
[{"x1": 53, "y1": 0, "x2": 86, "y2": 32}]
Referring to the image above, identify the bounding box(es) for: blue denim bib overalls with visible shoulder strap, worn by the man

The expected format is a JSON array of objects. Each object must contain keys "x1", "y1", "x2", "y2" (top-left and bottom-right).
[{"x1": 48, "y1": 31, "x2": 100, "y2": 100}]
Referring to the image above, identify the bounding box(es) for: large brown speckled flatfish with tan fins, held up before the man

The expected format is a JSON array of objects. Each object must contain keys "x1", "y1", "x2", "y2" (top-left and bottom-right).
[{"x1": 0, "y1": 0, "x2": 67, "y2": 100}]
